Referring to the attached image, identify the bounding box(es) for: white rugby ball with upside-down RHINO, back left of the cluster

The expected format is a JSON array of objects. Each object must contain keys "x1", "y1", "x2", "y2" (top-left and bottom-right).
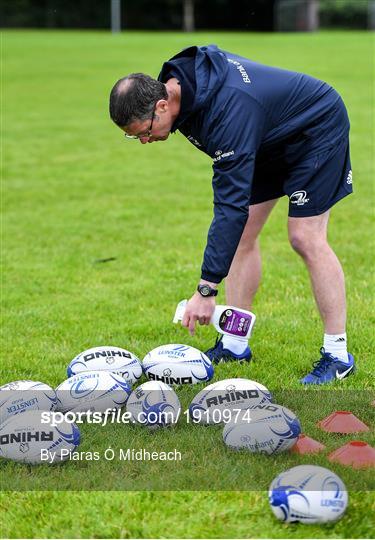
[{"x1": 67, "y1": 345, "x2": 142, "y2": 384}]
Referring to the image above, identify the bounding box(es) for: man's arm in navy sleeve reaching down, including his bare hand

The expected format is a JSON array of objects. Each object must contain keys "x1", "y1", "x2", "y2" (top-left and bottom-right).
[{"x1": 182, "y1": 92, "x2": 265, "y2": 335}]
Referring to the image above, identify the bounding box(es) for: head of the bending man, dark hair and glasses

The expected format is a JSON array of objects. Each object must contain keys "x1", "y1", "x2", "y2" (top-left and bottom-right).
[{"x1": 109, "y1": 73, "x2": 175, "y2": 143}]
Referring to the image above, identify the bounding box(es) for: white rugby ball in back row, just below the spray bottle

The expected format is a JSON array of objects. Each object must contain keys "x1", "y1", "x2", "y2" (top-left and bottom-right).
[{"x1": 143, "y1": 344, "x2": 214, "y2": 384}]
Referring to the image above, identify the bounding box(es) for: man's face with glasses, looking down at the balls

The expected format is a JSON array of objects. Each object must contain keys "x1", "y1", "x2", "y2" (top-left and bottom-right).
[{"x1": 122, "y1": 99, "x2": 173, "y2": 144}]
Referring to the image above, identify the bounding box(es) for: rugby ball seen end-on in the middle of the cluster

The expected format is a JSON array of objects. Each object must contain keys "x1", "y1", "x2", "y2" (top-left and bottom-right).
[{"x1": 126, "y1": 381, "x2": 181, "y2": 428}]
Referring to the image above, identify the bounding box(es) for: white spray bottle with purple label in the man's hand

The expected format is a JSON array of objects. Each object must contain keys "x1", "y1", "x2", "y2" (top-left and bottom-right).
[{"x1": 173, "y1": 300, "x2": 256, "y2": 341}]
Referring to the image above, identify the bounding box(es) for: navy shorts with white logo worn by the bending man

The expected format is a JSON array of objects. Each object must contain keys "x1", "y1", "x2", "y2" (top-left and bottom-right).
[{"x1": 250, "y1": 137, "x2": 353, "y2": 217}]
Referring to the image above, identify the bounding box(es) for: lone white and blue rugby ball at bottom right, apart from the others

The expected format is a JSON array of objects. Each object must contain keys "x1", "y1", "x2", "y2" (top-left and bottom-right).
[{"x1": 268, "y1": 465, "x2": 348, "y2": 523}]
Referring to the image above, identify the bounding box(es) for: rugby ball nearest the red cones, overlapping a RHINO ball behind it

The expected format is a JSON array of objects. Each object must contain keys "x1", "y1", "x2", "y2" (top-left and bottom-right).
[{"x1": 223, "y1": 403, "x2": 301, "y2": 455}]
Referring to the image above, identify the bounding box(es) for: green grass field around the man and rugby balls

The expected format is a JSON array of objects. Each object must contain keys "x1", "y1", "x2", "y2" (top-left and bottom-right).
[{"x1": 0, "y1": 31, "x2": 375, "y2": 538}]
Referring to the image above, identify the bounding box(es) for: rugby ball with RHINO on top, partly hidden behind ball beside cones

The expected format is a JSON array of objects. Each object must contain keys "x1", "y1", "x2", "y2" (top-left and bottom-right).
[{"x1": 189, "y1": 378, "x2": 272, "y2": 424}]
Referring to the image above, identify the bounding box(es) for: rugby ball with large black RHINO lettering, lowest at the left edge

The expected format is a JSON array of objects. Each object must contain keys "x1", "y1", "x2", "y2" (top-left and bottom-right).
[{"x1": 0, "y1": 411, "x2": 80, "y2": 463}]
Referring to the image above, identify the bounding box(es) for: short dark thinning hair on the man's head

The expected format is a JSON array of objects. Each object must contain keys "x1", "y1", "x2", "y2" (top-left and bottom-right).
[{"x1": 109, "y1": 73, "x2": 168, "y2": 127}]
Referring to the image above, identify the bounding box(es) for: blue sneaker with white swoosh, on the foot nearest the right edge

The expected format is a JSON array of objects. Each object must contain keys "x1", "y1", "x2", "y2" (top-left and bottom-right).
[{"x1": 300, "y1": 347, "x2": 355, "y2": 384}]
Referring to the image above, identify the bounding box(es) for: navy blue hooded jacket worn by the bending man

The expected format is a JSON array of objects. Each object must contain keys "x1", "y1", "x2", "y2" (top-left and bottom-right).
[{"x1": 159, "y1": 45, "x2": 348, "y2": 283}]
